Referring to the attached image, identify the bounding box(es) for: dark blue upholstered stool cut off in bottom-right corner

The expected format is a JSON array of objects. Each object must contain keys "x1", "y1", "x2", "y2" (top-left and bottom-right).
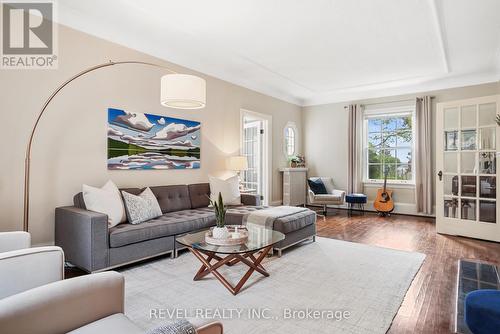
[{"x1": 465, "y1": 290, "x2": 500, "y2": 334}]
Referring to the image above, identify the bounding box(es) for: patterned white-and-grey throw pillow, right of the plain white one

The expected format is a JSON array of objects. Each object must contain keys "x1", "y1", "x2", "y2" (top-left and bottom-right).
[{"x1": 122, "y1": 188, "x2": 162, "y2": 224}]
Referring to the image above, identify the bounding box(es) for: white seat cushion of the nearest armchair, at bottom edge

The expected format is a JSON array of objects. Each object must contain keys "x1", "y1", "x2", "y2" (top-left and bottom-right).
[{"x1": 69, "y1": 313, "x2": 143, "y2": 334}]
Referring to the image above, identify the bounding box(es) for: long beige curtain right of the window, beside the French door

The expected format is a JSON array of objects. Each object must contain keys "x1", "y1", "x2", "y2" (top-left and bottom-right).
[{"x1": 414, "y1": 96, "x2": 433, "y2": 214}]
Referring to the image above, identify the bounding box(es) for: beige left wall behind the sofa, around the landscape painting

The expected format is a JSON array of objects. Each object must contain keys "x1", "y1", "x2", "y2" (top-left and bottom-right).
[{"x1": 0, "y1": 22, "x2": 301, "y2": 244}]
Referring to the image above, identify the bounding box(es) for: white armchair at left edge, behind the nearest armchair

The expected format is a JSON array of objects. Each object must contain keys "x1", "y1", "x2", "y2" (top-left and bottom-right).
[{"x1": 0, "y1": 232, "x2": 64, "y2": 299}]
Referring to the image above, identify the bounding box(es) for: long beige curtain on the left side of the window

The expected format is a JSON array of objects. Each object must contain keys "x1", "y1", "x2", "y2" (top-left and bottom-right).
[{"x1": 347, "y1": 104, "x2": 363, "y2": 193}]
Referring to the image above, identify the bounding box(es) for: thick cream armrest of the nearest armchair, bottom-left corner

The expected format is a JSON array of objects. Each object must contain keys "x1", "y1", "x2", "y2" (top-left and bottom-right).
[{"x1": 0, "y1": 271, "x2": 125, "y2": 334}]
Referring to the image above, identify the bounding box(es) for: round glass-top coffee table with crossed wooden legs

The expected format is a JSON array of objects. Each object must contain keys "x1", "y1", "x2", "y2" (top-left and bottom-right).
[{"x1": 176, "y1": 225, "x2": 285, "y2": 295}]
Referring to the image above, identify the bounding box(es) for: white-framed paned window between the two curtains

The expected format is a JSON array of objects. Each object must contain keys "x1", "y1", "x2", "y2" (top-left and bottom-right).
[{"x1": 364, "y1": 108, "x2": 414, "y2": 183}]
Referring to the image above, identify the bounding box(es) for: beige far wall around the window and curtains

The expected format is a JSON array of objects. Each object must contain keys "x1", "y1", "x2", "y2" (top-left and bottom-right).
[{"x1": 302, "y1": 82, "x2": 500, "y2": 214}]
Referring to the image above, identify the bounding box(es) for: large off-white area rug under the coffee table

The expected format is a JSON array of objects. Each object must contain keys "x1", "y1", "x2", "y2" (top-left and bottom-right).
[{"x1": 121, "y1": 238, "x2": 425, "y2": 334}]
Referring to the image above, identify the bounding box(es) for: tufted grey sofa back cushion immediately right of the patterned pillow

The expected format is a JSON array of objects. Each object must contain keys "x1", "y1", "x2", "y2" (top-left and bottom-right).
[{"x1": 151, "y1": 184, "x2": 191, "y2": 213}]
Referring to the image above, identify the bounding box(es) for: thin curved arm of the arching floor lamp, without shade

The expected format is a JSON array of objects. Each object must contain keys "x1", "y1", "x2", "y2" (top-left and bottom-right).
[{"x1": 23, "y1": 60, "x2": 177, "y2": 232}]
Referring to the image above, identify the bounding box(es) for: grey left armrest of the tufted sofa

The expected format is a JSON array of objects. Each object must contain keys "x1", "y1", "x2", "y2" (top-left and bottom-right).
[{"x1": 55, "y1": 206, "x2": 109, "y2": 272}]
